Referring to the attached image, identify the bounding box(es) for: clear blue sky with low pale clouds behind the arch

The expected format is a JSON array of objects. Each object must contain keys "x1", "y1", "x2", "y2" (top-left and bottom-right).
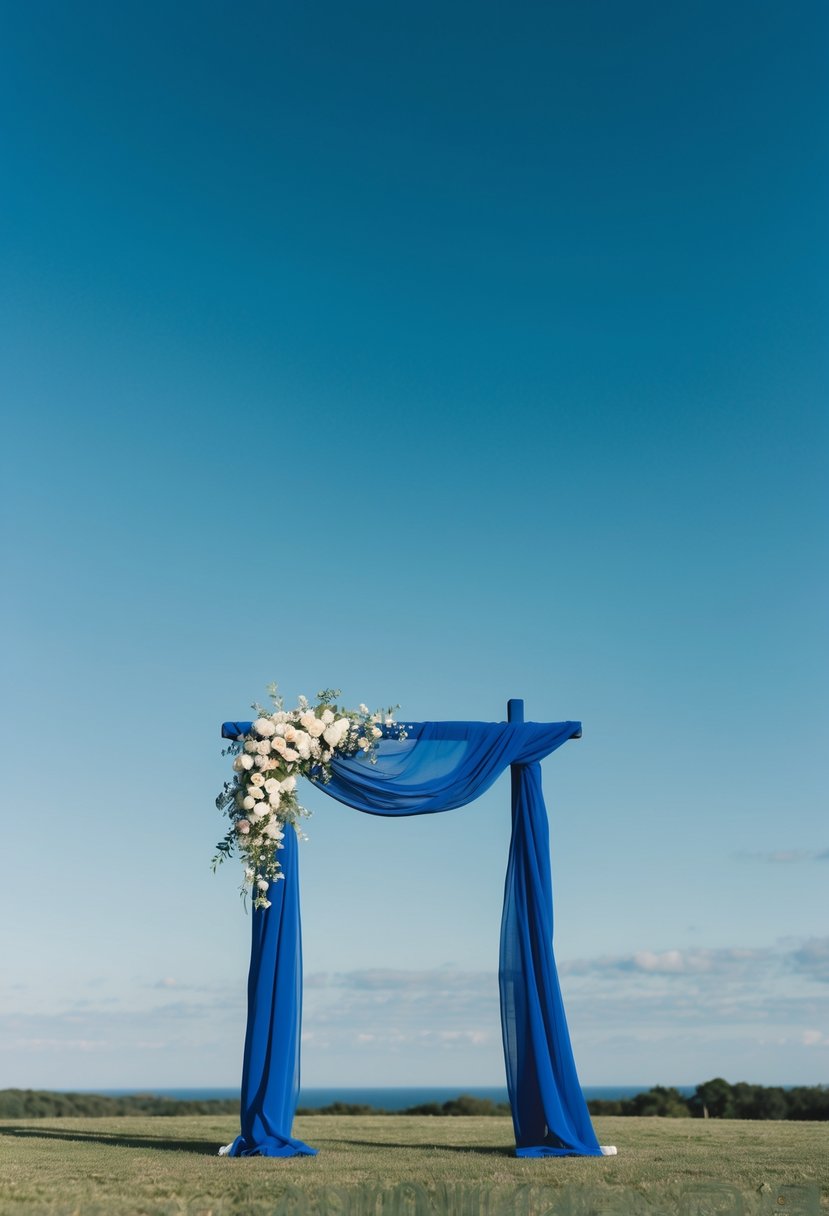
[{"x1": 0, "y1": 0, "x2": 829, "y2": 1088}]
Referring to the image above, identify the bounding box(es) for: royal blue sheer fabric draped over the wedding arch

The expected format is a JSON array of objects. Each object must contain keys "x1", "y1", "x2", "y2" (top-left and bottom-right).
[{"x1": 222, "y1": 722, "x2": 602, "y2": 1156}]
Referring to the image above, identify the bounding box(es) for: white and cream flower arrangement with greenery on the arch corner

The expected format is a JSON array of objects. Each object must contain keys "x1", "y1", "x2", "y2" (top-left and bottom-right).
[{"x1": 213, "y1": 685, "x2": 406, "y2": 908}]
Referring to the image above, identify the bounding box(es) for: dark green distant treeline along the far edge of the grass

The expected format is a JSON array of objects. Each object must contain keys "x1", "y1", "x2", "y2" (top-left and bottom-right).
[{"x1": 0, "y1": 1076, "x2": 829, "y2": 1120}]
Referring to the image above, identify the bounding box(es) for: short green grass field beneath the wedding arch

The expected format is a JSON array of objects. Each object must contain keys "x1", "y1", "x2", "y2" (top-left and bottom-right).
[{"x1": 0, "y1": 1115, "x2": 829, "y2": 1216}]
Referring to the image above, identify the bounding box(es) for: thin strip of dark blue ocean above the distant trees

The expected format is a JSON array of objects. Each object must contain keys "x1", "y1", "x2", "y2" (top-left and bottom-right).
[{"x1": 71, "y1": 1085, "x2": 695, "y2": 1110}]
